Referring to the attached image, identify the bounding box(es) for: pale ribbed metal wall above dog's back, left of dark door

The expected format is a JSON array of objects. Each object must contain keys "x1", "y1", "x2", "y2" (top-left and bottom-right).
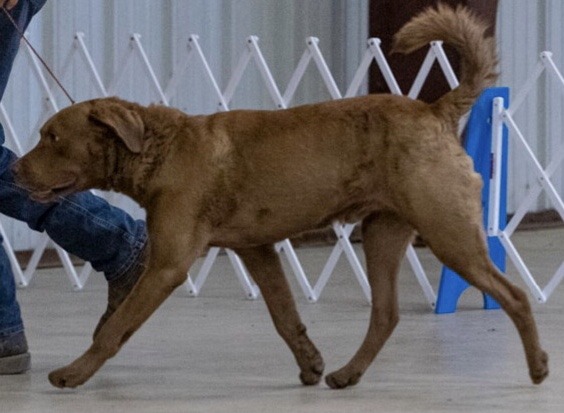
[{"x1": 41, "y1": 0, "x2": 367, "y2": 112}]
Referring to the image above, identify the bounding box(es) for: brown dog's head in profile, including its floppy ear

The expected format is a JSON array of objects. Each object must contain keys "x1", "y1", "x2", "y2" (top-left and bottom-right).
[{"x1": 12, "y1": 98, "x2": 144, "y2": 202}]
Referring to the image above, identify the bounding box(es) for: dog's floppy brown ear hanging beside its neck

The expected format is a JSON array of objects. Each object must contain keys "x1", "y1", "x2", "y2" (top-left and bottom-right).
[{"x1": 89, "y1": 101, "x2": 145, "y2": 153}]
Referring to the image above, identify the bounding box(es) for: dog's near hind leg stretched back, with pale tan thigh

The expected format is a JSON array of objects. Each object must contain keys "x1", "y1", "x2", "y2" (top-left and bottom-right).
[{"x1": 405, "y1": 166, "x2": 548, "y2": 384}]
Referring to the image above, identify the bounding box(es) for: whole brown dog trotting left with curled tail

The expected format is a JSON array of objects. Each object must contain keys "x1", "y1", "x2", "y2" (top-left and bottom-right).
[{"x1": 14, "y1": 6, "x2": 548, "y2": 388}]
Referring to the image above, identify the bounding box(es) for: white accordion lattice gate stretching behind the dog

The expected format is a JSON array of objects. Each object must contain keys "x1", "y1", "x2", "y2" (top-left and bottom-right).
[{"x1": 0, "y1": 33, "x2": 564, "y2": 307}]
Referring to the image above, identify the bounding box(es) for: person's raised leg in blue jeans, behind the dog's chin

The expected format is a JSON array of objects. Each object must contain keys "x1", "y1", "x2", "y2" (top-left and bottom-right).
[{"x1": 0, "y1": 147, "x2": 147, "y2": 281}]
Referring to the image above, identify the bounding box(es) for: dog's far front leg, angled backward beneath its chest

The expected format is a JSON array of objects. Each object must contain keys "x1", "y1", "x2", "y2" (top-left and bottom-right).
[{"x1": 235, "y1": 245, "x2": 324, "y2": 385}]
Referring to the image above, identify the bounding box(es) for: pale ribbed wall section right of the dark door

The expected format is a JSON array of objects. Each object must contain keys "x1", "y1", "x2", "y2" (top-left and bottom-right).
[{"x1": 497, "y1": 0, "x2": 564, "y2": 210}]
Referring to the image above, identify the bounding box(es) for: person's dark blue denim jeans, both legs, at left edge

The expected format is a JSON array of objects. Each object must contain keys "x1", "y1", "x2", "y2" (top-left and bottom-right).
[{"x1": 0, "y1": 0, "x2": 147, "y2": 337}]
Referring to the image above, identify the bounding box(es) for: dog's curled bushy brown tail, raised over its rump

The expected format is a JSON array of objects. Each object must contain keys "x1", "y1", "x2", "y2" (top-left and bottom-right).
[{"x1": 392, "y1": 4, "x2": 498, "y2": 125}]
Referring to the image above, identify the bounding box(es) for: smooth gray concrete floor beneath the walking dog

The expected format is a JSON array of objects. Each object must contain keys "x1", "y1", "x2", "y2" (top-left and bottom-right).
[{"x1": 0, "y1": 229, "x2": 564, "y2": 413}]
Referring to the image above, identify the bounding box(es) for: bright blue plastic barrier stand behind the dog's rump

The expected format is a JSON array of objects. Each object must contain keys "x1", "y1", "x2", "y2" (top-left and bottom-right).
[{"x1": 435, "y1": 87, "x2": 509, "y2": 314}]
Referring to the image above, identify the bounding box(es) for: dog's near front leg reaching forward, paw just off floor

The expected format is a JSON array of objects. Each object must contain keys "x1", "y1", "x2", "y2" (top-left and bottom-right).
[{"x1": 49, "y1": 211, "x2": 205, "y2": 388}]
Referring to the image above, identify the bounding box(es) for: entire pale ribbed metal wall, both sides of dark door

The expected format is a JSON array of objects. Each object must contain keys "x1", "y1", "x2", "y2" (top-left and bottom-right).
[{"x1": 1, "y1": 0, "x2": 564, "y2": 249}]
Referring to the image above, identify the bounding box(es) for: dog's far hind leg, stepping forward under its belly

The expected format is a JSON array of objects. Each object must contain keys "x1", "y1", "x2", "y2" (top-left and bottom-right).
[{"x1": 325, "y1": 212, "x2": 413, "y2": 389}]
